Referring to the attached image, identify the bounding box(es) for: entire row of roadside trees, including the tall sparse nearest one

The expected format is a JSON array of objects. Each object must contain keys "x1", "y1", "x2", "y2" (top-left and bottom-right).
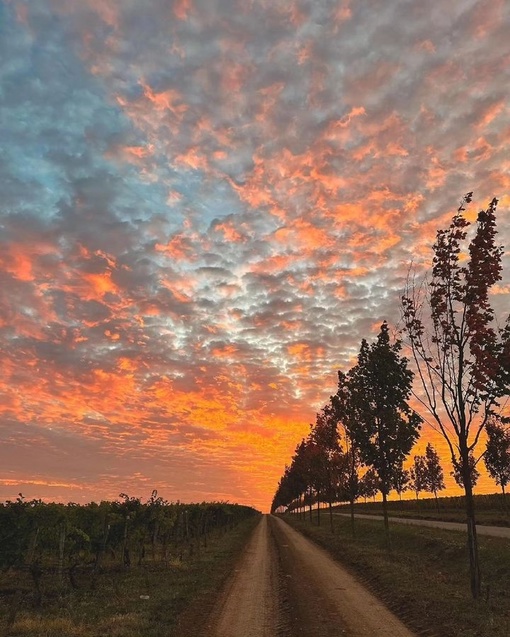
[{"x1": 273, "y1": 193, "x2": 510, "y2": 597}]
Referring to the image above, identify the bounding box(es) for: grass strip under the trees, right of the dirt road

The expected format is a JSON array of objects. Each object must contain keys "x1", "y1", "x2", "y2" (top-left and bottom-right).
[{"x1": 283, "y1": 514, "x2": 510, "y2": 637}]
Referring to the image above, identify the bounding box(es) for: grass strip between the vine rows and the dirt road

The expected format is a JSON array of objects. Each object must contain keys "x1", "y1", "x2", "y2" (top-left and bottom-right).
[{"x1": 0, "y1": 516, "x2": 259, "y2": 637}]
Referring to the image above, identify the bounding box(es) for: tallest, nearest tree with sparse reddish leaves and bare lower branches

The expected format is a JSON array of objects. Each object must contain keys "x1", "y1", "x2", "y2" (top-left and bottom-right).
[{"x1": 402, "y1": 193, "x2": 510, "y2": 597}]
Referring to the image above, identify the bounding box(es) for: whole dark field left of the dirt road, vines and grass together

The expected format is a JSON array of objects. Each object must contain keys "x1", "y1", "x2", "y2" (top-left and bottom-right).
[{"x1": 0, "y1": 499, "x2": 259, "y2": 637}]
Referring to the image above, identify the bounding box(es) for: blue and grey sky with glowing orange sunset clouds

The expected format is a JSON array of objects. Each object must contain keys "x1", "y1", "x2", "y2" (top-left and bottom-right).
[{"x1": 0, "y1": 0, "x2": 510, "y2": 510}]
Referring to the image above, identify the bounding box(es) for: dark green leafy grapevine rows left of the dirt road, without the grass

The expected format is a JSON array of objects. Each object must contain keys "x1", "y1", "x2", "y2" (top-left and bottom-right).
[{"x1": 0, "y1": 491, "x2": 255, "y2": 570}]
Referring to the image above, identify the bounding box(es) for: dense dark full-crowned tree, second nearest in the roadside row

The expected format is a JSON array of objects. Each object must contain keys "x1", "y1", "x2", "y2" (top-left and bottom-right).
[{"x1": 346, "y1": 321, "x2": 422, "y2": 541}]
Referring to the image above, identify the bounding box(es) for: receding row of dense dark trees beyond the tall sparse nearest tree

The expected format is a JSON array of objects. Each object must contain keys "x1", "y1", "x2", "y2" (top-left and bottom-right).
[{"x1": 272, "y1": 322, "x2": 422, "y2": 528}]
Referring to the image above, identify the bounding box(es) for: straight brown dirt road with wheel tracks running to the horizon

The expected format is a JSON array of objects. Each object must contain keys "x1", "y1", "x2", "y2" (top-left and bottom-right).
[{"x1": 208, "y1": 515, "x2": 413, "y2": 637}]
